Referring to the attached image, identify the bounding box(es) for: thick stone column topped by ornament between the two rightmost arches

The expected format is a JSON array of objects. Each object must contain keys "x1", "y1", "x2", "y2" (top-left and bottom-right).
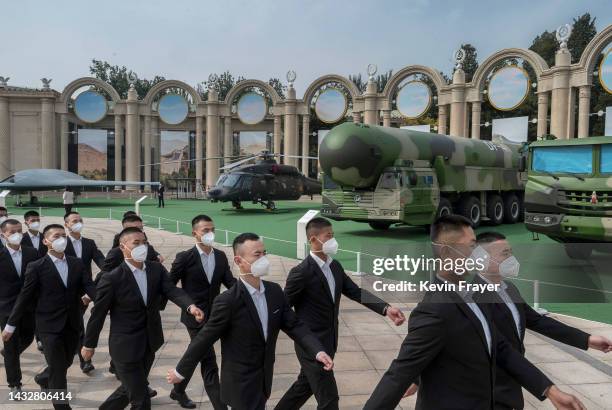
[{"x1": 550, "y1": 48, "x2": 571, "y2": 139}]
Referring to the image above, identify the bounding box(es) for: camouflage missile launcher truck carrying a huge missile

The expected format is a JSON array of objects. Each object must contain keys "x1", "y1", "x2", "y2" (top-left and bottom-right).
[{"x1": 319, "y1": 123, "x2": 526, "y2": 229}]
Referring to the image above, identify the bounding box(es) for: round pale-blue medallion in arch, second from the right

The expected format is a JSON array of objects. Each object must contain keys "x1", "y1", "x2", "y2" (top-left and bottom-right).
[{"x1": 487, "y1": 65, "x2": 529, "y2": 111}]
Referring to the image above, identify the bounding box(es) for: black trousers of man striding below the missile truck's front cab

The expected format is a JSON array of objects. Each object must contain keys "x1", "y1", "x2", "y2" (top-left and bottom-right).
[{"x1": 274, "y1": 346, "x2": 340, "y2": 410}]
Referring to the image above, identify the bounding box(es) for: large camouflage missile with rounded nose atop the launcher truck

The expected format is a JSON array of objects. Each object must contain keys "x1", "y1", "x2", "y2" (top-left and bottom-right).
[{"x1": 319, "y1": 122, "x2": 521, "y2": 188}]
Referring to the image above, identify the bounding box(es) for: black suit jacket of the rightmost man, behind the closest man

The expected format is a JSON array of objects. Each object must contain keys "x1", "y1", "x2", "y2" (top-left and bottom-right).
[{"x1": 475, "y1": 276, "x2": 589, "y2": 409}]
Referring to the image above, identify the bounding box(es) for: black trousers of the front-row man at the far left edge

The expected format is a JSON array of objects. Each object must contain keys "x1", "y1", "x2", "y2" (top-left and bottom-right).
[{"x1": 0, "y1": 313, "x2": 34, "y2": 387}]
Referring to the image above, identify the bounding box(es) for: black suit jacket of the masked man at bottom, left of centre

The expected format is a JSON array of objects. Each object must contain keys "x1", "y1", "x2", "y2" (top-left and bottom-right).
[{"x1": 176, "y1": 281, "x2": 325, "y2": 409}]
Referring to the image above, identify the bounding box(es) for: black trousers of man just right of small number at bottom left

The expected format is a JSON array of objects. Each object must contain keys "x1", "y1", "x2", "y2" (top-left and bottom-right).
[{"x1": 100, "y1": 348, "x2": 155, "y2": 410}]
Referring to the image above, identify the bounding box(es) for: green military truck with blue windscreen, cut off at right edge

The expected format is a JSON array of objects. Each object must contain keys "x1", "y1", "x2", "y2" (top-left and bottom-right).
[{"x1": 525, "y1": 137, "x2": 612, "y2": 259}]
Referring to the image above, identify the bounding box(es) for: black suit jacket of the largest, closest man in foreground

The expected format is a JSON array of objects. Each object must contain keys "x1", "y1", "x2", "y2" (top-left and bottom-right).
[{"x1": 365, "y1": 284, "x2": 553, "y2": 410}]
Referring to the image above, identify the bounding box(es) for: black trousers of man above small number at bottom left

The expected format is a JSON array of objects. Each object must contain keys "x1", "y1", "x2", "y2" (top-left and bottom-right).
[{"x1": 39, "y1": 324, "x2": 79, "y2": 409}]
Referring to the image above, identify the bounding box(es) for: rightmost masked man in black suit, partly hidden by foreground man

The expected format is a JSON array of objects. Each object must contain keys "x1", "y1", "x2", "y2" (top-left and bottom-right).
[{"x1": 474, "y1": 232, "x2": 612, "y2": 410}]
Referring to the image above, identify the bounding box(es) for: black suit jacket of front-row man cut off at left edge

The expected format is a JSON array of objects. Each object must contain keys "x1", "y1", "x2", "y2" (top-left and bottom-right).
[{"x1": 0, "y1": 246, "x2": 39, "y2": 316}]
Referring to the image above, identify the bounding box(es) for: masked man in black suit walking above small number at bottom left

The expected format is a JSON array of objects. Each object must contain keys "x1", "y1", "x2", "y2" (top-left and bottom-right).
[{"x1": 2, "y1": 224, "x2": 96, "y2": 409}]
